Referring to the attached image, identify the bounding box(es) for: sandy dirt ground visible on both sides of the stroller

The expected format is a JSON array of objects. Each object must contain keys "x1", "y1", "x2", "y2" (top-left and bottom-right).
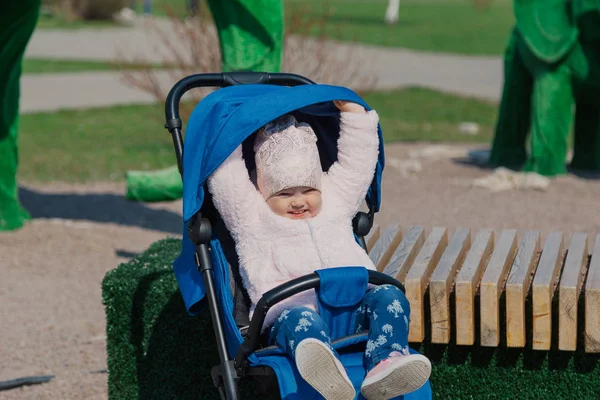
[{"x1": 0, "y1": 145, "x2": 600, "y2": 400}]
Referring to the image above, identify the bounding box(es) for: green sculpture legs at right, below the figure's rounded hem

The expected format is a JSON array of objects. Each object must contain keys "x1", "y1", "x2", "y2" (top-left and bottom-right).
[{"x1": 490, "y1": 30, "x2": 600, "y2": 176}]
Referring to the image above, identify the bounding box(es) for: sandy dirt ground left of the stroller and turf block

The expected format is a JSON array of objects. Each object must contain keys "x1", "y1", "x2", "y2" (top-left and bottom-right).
[{"x1": 0, "y1": 184, "x2": 181, "y2": 400}]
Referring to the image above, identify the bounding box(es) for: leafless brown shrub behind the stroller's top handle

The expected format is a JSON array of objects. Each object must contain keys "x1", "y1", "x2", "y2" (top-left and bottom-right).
[{"x1": 119, "y1": 2, "x2": 375, "y2": 118}]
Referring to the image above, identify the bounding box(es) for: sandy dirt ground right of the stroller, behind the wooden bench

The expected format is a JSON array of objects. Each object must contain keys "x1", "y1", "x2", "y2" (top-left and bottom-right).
[{"x1": 379, "y1": 145, "x2": 600, "y2": 234}]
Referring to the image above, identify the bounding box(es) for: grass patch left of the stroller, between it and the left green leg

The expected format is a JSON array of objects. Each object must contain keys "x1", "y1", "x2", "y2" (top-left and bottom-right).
[{"x1": 19, "y1": 105, "x2": 175, "y2": 181}]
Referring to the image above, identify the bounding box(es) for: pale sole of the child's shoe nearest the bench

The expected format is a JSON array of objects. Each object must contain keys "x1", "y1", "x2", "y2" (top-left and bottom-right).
[{"x1": 360, "y1": 355, "x2": 431, "y2": 400}]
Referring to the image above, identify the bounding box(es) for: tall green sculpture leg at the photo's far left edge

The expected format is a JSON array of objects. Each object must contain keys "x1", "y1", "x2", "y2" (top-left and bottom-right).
[{"x1": 0, "y1": 0, "x2": 41, "y2": 231}]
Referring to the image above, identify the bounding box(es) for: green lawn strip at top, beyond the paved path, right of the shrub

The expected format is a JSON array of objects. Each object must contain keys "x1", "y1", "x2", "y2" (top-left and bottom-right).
[{"x1": 285, "y1": 0, "x2": 514, "y2": 55}]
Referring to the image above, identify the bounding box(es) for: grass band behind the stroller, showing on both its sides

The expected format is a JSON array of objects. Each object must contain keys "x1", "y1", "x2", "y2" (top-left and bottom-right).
[{"x1": 19, "y1": 88, "x2": 496, "y2": 181}]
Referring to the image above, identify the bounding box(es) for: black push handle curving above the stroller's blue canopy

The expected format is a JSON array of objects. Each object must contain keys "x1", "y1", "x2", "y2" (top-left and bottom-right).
[{"x1": 165, "y1": 72, "x2": 314, "y2": 176}]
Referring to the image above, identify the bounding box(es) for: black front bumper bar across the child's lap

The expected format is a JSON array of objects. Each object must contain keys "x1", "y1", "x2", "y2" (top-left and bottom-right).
[{"x1": 235, "y1": 270, "x2": 405, "y2": 368}]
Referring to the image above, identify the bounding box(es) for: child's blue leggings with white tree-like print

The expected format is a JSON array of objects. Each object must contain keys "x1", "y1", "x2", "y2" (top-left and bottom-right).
[{"x1": 269, "y1": 285, "x2": 410, "y2": 372}]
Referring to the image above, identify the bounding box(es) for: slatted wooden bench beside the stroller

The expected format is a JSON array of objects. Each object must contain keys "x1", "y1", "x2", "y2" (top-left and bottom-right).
[{"x1": 366, "y1": 225, "x2": 600, "y2": 353}]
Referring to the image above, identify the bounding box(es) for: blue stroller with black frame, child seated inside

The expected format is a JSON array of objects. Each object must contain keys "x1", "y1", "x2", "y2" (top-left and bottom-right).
[{"x1": 165, "y1": 72, "x2": 431, "y2": 400}]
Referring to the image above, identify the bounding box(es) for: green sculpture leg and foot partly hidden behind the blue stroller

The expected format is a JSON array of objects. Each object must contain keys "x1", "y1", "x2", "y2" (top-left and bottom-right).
[{"x1": 126, "y1": 0, "x2": 283, "y2": 201}]
